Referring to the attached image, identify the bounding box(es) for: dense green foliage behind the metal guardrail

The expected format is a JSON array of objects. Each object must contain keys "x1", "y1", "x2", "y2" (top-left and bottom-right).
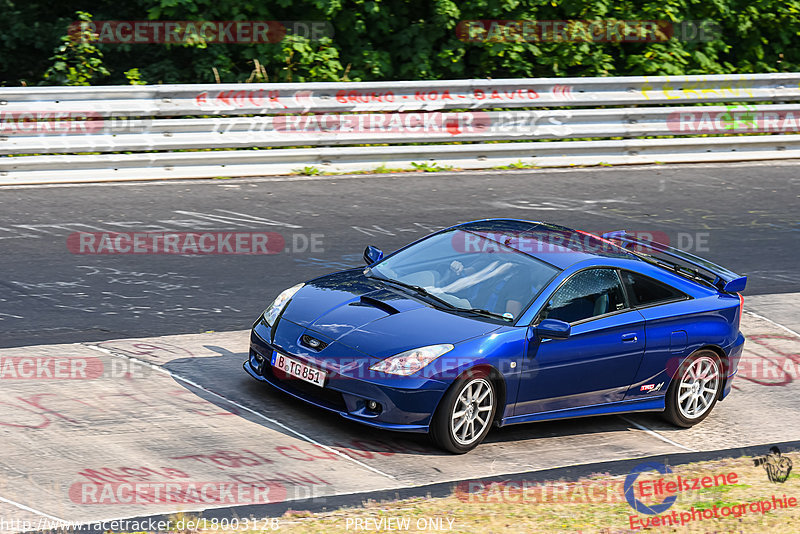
[{"x1": 0, "y1": 0, "x2": 800, "y2": 85}]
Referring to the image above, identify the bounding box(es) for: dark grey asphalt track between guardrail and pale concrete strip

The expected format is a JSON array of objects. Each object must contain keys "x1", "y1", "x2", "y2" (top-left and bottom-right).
[{"x1": 0, "y1": 162, "x2": 800, "y2": 347}]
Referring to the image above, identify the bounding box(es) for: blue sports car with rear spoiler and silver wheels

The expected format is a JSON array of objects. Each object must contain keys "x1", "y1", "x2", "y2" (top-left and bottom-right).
[{"x1": 244, "y1": 219, "x2": 747, "y2": 453}]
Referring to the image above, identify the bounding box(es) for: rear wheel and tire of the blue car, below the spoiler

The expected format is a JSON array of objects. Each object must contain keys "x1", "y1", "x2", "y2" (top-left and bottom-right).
[{"x1": 664, "y1": 350, "x2": 724, "y2": 428}]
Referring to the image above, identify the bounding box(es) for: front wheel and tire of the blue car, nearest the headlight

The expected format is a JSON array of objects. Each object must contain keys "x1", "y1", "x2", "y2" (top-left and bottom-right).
[{"x1": 430, "y1": 371, "x2": 498, "y2": 454}]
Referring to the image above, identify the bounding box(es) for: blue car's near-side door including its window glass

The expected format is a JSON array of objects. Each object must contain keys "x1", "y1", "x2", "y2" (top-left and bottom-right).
[{"x1": 514, "y1": 267, "x2": 645, "y2": 415}]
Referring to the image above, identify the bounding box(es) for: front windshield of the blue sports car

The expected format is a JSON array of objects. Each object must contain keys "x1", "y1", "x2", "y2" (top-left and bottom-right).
[{"x1": 371, "y1": 229, "x2": 559, "y2": 320}]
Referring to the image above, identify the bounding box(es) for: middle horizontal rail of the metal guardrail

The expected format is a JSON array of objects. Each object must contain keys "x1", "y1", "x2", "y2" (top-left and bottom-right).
[{"x1": 0, "y1": 104, "x2": 800, "y2": 154}]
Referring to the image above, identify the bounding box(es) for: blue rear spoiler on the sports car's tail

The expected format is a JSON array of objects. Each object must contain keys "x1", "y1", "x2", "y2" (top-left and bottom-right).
[{"x1": 603, "y1": 230, "x2": 747, "y2": 293}]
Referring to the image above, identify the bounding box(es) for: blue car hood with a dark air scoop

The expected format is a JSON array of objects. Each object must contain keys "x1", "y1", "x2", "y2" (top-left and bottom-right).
[{"x1": 278, "y1": 270, "x2": 500, "y2": 359}]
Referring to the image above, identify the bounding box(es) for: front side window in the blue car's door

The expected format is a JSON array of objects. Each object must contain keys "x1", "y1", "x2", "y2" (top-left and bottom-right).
[{"x1": 541, "y1": 269, "x2": 626, "y2": 323}]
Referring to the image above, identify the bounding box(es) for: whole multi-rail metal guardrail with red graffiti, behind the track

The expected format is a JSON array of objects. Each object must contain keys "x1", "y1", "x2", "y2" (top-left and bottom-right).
[{"x1": 0, "y1": 73, "x2": 800, "y2": 184}]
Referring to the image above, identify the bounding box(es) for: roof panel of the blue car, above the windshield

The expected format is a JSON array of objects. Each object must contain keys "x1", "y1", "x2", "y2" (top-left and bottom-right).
[{"x1": 452, "y1": 219, "x2": 642, "y2": 269}]
